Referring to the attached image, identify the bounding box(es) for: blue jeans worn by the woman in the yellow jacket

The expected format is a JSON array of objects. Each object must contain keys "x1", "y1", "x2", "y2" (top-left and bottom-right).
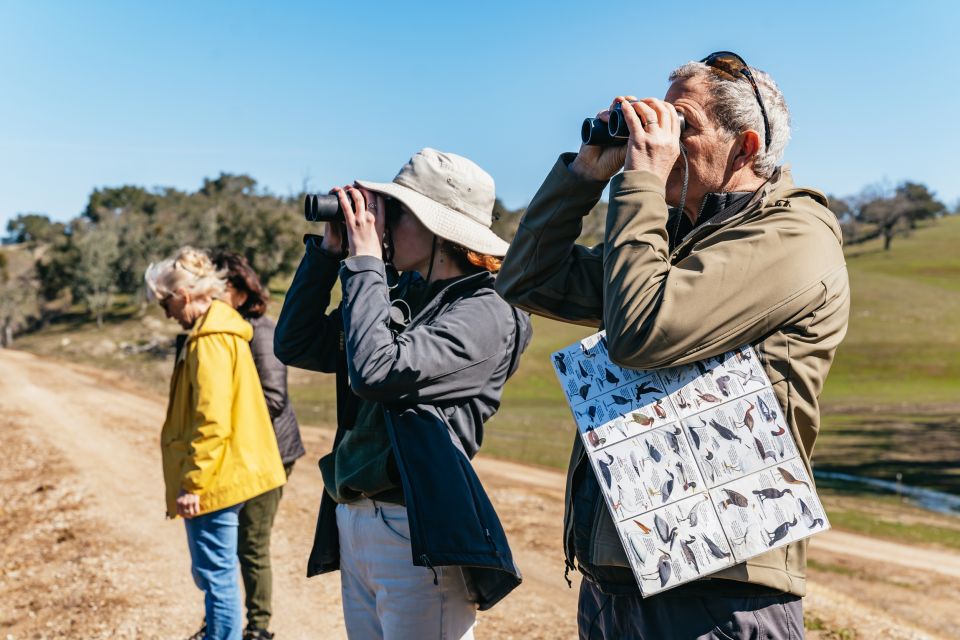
[{"x1": 183, "y1": 504, "x2": 243, "y2": 640}]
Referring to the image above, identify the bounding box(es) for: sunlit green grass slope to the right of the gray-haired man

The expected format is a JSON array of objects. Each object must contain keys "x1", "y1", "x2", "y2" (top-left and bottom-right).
[{"x1": 823, "y1": 217, "x2": 960, "y2": 411}]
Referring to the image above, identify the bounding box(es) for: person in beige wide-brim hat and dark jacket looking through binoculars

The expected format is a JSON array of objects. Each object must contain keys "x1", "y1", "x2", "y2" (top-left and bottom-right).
[{"x1": 274, "y1": 149, "x2": 531, "y2": 640}]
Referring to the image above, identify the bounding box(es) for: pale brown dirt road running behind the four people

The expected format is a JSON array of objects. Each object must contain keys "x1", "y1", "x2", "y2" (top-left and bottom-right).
[{"x1": 0, "y1": 350, "x2": 960, "y2": 640}]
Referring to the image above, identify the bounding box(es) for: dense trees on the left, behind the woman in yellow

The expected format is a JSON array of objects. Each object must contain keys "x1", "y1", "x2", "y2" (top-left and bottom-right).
[{"x1": 7, "y1": 174, "x2": 303, "y2": 336}]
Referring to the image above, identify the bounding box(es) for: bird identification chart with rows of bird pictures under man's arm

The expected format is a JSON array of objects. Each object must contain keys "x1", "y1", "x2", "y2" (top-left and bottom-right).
[{"x1": 553, "y1": 332, "x2": 830, "y2": 596}]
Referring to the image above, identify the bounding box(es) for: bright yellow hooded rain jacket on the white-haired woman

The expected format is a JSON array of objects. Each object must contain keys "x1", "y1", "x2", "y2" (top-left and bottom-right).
[{"x1": 160, "y1": 301, "x2": 286, "y2": 518}]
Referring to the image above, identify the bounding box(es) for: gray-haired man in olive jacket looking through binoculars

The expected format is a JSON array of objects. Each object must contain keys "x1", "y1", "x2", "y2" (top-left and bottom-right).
[{"x1": 497, "y1": 52, "x2": 850, "y2": 639}]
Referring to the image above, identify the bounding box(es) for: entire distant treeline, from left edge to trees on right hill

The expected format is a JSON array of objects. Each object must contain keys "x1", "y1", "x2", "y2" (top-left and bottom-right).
[{"x1": 0, "y1": 174, "x2": 947, "y2": 344}]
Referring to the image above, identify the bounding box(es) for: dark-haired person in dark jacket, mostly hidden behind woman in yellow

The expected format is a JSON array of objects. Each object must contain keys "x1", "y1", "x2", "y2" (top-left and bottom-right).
[{"x1": 213, "y1": 251, "x2": 306, "y2": 640}]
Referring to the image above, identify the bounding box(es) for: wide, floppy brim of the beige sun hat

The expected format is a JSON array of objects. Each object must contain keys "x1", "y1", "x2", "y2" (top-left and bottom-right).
[{"x1": 357, "y1": 180, "x2": 510, "y2": 258}]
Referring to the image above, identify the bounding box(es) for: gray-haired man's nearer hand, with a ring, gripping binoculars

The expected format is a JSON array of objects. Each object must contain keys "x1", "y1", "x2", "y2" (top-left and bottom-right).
[{"x1": 621, "y1": 98, "x2": 680, "y2": 184}]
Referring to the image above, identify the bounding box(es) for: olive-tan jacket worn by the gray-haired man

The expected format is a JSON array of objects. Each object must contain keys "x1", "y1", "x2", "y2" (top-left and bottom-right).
[{"x1": 496, "y1": 156, "x2": 850, "y2": 596}]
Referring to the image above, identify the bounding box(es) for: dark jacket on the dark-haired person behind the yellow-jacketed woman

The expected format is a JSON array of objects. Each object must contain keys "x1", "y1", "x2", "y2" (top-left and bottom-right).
[{"x1": 245, "y1": 316, "x2": 306, "y2": 465}]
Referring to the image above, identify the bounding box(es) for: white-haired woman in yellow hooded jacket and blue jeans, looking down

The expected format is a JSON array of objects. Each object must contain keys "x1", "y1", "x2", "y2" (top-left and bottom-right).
[{"x1": 145, "y1": 247, "x2": 286, "y2": 640}]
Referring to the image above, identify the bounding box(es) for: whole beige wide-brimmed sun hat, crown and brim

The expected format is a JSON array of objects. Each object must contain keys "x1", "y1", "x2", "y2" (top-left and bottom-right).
[{"x1": 357, "y1": 148, "x2": 510, "y2": 257}]
